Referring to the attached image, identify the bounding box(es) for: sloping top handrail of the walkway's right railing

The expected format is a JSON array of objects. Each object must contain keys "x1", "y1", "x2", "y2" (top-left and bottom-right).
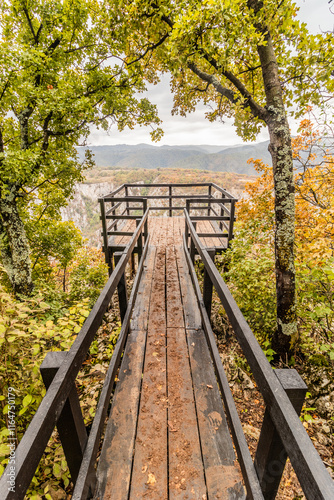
[{"x1": 185, "y1": 211, "x2": 334, "y2": 500}]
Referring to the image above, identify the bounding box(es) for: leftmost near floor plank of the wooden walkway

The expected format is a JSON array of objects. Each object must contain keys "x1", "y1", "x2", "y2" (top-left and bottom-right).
[{"x1": 94, "y1": 330, "x2": 146, "y2": 500}]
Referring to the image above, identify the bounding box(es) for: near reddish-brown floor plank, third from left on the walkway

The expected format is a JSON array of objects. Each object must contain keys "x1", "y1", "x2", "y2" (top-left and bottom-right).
[{"x1": 167, "y1": 328, "x2": 206, "y2": 500}]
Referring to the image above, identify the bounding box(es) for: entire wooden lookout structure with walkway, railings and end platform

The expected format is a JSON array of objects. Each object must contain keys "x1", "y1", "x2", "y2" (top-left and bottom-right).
[{"x1": 0, "y1": 183, "x2": 334, "y2": 500}]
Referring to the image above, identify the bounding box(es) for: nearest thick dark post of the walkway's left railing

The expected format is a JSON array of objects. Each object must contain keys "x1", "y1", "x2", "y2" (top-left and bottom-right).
[{"x1": 40, "y1": 351, "x2": 87, "y2": 484}]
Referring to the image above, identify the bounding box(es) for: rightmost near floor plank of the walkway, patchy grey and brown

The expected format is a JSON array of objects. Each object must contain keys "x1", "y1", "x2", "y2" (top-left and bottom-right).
[{"x1": 187, "y1": 330, "x2": 245, "y2": 500}]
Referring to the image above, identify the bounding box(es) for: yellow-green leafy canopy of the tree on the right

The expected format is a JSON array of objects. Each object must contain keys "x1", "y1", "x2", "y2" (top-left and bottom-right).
[{"x1": 111, "y1": 0, "x2": 334, "y2": 140}]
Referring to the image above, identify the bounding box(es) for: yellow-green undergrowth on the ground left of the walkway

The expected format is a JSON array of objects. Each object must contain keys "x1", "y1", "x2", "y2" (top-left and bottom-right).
[{"x1": 0, "y1": 243, "x2": 109, "y2": 500}]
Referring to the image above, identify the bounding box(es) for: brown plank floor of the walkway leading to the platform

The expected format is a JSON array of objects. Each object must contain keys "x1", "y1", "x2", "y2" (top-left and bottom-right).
[{"x1": 95, "y1": 217, "x2": 245, "y2": 500}]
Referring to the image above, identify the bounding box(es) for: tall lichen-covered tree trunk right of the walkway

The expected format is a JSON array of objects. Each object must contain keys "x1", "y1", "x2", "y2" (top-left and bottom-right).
[{"x1": 251, "y1": 2, "x2": 297, "y2": 356}]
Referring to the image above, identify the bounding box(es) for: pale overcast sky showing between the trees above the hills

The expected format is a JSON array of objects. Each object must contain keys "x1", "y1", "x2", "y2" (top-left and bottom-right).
[{"x1": 88, "y1": 0, "x2": 334, "y2": 146}]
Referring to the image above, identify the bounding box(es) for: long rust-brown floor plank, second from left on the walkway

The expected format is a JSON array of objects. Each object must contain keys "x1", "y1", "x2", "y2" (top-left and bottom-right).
[{"x1": 129, "y1": 248, "x2": 168, "y2": 500}]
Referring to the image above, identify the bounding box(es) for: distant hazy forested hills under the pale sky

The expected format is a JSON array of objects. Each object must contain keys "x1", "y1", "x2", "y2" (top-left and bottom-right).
[{"x1": 78, "y1": 141, "x2": 271, "y2": 175}]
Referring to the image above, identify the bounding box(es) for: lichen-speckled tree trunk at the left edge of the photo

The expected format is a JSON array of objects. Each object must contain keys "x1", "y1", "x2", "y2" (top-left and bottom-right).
[{"x1": 0, "y1": 188, "x2": 33, "y2": 295}]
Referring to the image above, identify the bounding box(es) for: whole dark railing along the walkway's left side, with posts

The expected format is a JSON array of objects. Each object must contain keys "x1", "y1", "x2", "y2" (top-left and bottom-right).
[{"x1": 0, "y1": 210, "x2": 149, "y2": 500}]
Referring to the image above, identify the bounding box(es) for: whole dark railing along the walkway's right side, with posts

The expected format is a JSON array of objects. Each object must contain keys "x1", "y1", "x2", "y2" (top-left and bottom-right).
[{"x1": 184, "y1": 210, "x2": 334, "y2": 500}]
